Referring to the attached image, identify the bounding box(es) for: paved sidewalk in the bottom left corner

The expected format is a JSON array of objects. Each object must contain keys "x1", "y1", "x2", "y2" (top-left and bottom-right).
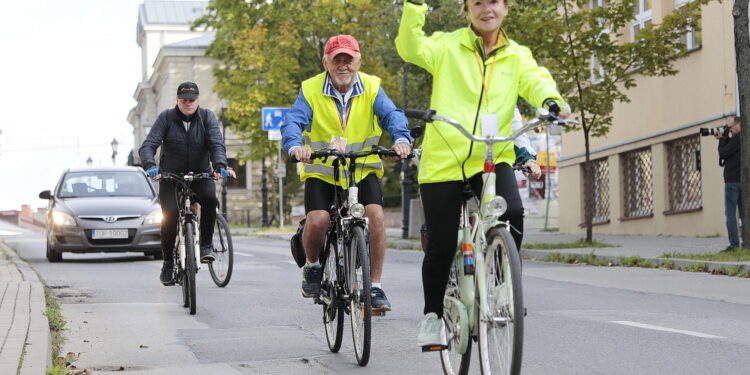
[{"x1": 0, "y1": 241, "x2": 52, "y2": 375}]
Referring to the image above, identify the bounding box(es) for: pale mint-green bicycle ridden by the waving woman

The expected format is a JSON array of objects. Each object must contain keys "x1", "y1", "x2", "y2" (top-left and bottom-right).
[{"x1": 405, "y1": 109, "x2": 575, "y2": 374}]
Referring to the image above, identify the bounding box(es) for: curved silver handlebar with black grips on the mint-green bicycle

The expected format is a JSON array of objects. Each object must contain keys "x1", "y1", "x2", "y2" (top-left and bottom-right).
[{"x1": 404, "y1": 108, "x2": 578, "y2": 144}]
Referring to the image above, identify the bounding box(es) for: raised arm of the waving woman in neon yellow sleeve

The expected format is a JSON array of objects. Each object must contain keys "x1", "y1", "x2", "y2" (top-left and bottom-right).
[{"x1": 396, "y1": 1, "x2": 442, "y2": 73}]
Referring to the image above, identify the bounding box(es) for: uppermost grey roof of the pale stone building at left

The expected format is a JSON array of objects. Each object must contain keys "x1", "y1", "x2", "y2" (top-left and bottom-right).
[{"x1": 138, "y1": 0, "x2": 208, "y2": 25}]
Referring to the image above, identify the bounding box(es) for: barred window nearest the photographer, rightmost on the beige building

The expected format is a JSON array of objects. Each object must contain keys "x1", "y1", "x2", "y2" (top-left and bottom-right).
[{"x1": 667, "y1": 134, "x2": 703, "y2": 213}]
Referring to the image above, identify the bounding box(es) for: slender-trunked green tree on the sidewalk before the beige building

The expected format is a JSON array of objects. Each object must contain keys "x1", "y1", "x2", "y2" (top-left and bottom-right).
[{"x1": 505, "y1": 0, "x2": 712, "y2": 242}]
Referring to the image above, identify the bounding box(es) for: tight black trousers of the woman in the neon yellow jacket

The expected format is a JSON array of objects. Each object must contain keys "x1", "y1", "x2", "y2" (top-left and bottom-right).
[{"x1": 419, "y1": 163, "x2": 523, "y2": 317}]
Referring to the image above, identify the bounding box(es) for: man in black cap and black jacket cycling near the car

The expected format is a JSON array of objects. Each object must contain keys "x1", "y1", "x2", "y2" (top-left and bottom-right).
[{"x1": 138, "y1": 82, "x2": 234, "y2": 285}]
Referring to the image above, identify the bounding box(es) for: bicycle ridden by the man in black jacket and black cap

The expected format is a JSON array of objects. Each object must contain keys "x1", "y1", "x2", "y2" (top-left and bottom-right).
[{"x1": 161, "y1": 172, "x2": 215, "y2": 315}]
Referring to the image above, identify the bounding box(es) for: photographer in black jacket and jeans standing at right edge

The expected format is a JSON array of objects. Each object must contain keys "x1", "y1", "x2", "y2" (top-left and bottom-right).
[{"x1": 716, "y1": 116, "x2": 747, "y2": 251}]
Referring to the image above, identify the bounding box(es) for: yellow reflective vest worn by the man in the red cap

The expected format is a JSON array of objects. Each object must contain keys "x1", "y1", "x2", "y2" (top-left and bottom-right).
[{"x1": 300, "y1": 72, "x2": 383, "y2": 188}]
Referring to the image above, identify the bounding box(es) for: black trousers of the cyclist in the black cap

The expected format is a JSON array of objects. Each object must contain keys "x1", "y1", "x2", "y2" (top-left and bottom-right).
[{"x1": 159, "y1": 181, "x2": 219, "y2": 262}]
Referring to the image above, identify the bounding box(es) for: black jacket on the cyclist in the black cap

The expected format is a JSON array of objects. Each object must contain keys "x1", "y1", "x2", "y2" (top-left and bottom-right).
[{"x1": 138, "y1": 106, "x2": 227, "y2": 173}]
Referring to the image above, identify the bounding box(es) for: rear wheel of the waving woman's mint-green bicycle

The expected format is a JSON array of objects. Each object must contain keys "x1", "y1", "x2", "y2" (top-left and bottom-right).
[{"x1": 440, "y1": 259, "x2": 471, "y2": 375}]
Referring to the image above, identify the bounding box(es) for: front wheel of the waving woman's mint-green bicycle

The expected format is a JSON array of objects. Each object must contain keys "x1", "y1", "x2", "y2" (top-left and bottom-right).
[{"x1": 477, "y1": 227, "x2": 524, "y2": 374}]
